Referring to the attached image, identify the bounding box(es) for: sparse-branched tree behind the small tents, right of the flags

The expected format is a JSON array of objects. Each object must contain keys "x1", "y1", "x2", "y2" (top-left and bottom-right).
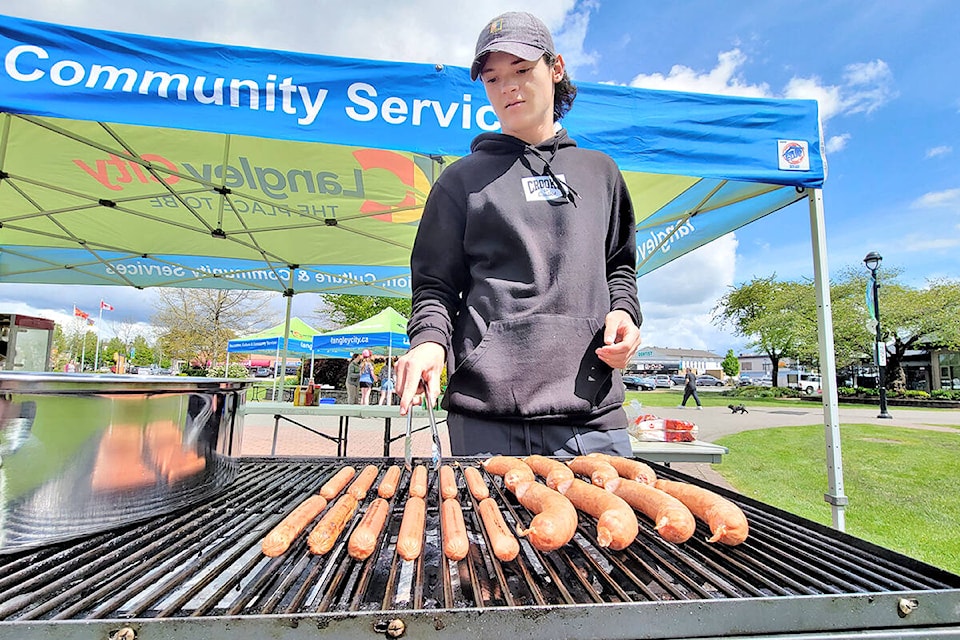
[{"x1": 153, "y1": 289, "x2": 273, "y2": 366}]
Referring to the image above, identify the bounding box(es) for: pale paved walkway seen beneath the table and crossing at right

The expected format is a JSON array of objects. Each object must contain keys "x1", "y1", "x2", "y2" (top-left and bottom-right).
[{"x1": 236, "y1": 400, "x2": 960, "y2": 489}]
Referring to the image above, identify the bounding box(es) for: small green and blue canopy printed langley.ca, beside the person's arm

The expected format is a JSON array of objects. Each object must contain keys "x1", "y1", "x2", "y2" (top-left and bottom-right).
[{"x1": 313, "y1": 307, "x2": 410, "y2": 358}]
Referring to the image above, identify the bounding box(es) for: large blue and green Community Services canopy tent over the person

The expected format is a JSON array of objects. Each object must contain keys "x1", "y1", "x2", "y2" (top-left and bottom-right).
[{"x1": 0, "y1": 16, "x2": 846, "y2": 528}]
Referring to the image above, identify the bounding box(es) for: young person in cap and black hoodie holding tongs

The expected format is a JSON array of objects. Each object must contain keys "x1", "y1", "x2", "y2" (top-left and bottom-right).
[{"x1": 397, "y1": 12, "x2": 641, "y2": 456}]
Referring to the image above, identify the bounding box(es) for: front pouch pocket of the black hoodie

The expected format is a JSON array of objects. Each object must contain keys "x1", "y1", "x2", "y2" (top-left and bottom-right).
[{"x1": 447, "y1": 315, "x2": 612, "y2": 417}]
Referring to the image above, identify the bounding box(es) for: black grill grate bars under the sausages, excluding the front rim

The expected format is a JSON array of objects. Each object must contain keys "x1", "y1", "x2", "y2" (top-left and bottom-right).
[{"x1": 0, "y1": 458, "x2": 960, "y2": 623}]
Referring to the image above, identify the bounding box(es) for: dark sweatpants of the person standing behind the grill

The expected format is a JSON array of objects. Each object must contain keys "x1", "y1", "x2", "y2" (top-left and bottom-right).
[{"x1": 447, "y1": 413, "x2": 633, "y2": 458}]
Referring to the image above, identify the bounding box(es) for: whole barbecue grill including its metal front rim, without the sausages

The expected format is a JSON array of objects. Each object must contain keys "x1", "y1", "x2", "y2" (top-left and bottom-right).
[{"x1": 0, "y1": 458, "x2": 960, "y2": 640}]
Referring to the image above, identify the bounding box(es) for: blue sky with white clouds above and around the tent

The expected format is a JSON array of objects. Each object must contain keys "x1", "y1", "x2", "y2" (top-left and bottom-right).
[{"x1": 0, "y1": 0, "x2": 960, "y2": 354}]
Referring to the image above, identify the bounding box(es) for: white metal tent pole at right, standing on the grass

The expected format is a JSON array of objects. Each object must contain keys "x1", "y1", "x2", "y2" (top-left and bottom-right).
[{"x1": 808, "y1": 189, "x2": 849, "y2": 531}]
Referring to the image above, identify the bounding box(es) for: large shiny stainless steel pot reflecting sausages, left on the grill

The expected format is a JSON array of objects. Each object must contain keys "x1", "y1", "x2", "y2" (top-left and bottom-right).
[{"x1": 0, "y1": 373, "x2": 247, "y2": 554}]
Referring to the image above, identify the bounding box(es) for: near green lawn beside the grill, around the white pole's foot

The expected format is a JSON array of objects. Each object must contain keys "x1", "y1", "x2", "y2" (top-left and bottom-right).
[{"x1": 713, "y1": 424, "x2": 960, "y2": 574}]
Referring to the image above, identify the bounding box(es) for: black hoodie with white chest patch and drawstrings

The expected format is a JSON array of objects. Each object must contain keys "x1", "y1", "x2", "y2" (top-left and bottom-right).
[{"x1": 407, "y1": 130, "x2": 641, "y2": 429}]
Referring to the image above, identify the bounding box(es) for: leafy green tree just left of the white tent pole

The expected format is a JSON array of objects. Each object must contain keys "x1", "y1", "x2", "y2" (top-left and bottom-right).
[{"x1": 714, "y1": 276, "x2": 816, "y2": 386}]
